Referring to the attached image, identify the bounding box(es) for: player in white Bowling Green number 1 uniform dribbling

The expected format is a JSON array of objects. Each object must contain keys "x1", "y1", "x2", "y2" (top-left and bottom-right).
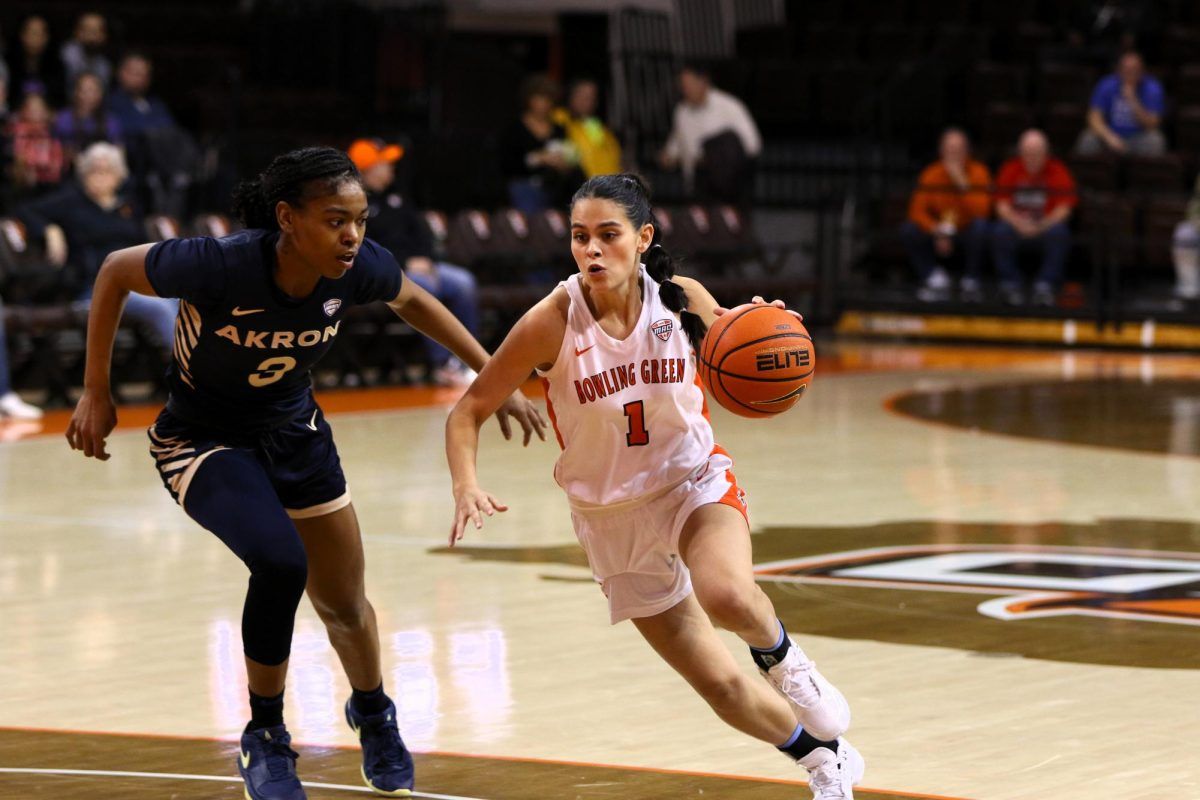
[{"x1": 446, "y1": 174, "x2": 864, "y2": 800}]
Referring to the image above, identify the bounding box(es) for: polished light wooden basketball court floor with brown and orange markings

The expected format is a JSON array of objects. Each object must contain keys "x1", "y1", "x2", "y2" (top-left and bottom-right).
[{"x1": 0, "y1": 345, "x2": 1200, "y2": 800}]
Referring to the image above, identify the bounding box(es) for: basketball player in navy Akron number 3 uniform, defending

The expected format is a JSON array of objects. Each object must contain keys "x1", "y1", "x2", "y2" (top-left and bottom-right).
[{"x1": 67, "y1": 148, "x2": 545, "y2": 800}]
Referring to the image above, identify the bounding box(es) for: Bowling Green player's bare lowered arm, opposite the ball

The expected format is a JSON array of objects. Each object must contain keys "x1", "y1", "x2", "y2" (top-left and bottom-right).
[{"x1": 446, "y1": 290, "x2": 566, "y2": 547}]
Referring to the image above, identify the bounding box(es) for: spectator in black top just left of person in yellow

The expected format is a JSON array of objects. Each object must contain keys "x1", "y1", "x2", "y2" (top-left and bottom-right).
[{"x1": 500, "y1": 74, "x2": 583, "y2": 213}]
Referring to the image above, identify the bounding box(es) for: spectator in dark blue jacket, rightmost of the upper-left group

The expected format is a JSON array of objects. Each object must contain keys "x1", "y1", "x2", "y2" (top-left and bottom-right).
[{"x1": 108, "y1": 53, "x2": 199, "y2": 217}]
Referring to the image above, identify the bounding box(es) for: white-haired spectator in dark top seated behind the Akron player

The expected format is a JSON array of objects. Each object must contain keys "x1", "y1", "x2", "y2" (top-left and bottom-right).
[{"x1": 17, "y1": 142, "x2": 178, "y2": 355}]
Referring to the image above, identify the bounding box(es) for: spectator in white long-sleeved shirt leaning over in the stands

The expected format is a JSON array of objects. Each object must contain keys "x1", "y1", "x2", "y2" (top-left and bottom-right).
[{"x1": 659, "y1": 64, "x2": 762, "y2": 205}]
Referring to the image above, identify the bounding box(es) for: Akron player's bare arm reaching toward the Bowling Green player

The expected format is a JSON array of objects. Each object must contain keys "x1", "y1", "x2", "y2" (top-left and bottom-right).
[{"x1": 388, "y1": 279, "x2": 546, "y2": 445}]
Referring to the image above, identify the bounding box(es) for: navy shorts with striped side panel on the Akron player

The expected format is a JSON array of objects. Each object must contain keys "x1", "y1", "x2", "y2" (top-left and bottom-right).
[{"x1": 146, "y1": 403, "x2": 350, "y2": 519}]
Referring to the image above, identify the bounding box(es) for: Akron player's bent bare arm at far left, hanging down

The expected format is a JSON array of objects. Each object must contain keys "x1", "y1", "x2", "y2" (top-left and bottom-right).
[{"x1": 67, "y1": 245, "x2": 157, "y2": 461}]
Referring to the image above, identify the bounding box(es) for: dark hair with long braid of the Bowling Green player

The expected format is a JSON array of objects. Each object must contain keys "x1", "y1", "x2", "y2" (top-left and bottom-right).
[{"x1": 571, "y1": 173, "x2": 707, "y2": 350}]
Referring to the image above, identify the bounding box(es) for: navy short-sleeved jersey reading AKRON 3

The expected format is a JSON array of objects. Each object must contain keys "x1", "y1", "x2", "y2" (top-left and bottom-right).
[{"x1": 146, "y1": 230, "x2": 402, "y2": 433}]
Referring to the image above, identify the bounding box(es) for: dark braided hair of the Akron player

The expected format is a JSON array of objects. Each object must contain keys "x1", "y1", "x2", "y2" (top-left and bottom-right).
[{"x1": 233, "y1": 148, "x2": 362, "y2": 230}]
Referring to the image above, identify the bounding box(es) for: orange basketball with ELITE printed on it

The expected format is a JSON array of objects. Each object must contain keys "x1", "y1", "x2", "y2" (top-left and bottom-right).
[{"x1": 698, "y1": 303, "x2": 816, "y2": 417}]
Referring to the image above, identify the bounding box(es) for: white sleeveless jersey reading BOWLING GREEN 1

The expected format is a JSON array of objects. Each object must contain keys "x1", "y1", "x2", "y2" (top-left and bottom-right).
[{"x1": 538, "y1": 269, "x2": 713, "y2": 505}]
